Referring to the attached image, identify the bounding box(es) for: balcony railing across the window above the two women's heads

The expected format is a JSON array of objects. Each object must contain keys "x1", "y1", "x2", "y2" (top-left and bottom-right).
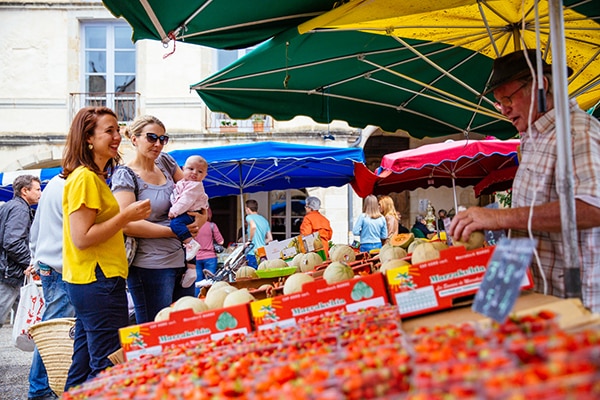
[{"x1": 69, "y1": 92, "x2": 140, "y2": 122}]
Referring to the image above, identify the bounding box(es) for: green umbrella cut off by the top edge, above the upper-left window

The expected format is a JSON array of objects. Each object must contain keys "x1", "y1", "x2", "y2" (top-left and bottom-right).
[{"x1": 103, "y1": 0, "x2": 336, "y2": 49}]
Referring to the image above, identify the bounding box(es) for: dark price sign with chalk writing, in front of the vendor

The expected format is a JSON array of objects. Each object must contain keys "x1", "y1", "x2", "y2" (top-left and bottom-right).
[{"x1": 472, "y1": 238, "x2": 535, "y2": 323}]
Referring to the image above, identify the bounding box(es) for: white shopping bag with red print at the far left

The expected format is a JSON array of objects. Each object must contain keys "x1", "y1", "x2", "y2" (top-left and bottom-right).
[{"x1": 12, "y1": 276, "x2": 46, "y2": 351}]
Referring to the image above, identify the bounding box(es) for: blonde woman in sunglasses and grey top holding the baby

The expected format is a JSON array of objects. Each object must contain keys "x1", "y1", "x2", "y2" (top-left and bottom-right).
[{"x1": 112, "y1": 115, "x2": 206, "y2": 324}]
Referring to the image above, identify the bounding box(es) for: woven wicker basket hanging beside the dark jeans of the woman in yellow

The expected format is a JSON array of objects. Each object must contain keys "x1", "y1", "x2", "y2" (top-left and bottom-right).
[{"x1": 29, "y1": 318, "x2": 75, "y2": 397}]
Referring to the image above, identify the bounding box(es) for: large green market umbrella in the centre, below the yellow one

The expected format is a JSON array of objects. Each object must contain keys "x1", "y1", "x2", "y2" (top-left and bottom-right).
[{"x1": 192, "y1": 28, "x2": 516, "y2": 138}]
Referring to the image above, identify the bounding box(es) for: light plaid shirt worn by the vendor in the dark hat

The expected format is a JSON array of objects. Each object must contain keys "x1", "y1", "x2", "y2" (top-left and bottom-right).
[{"x1": 512, "y1": 100, "x2": 600, "y2": 312}]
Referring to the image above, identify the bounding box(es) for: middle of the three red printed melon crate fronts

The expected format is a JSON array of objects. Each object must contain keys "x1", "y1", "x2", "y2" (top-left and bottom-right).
[{"x1": 250, "y1": 274, "x2": 388, "y2": 330}]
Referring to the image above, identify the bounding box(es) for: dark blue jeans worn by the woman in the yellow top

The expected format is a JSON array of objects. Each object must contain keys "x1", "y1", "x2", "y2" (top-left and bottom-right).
[{"x1": 65, "y1": 266, "x2": 129, "y2": 391}]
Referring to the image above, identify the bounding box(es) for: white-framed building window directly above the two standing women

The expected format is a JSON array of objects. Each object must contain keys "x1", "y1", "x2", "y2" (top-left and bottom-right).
[{"x1": 82, "y1": 22, "x2": 136, "y2": 121}]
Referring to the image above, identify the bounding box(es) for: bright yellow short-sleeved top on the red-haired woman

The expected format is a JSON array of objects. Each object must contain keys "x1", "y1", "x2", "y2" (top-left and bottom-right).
[{"x1": 63, "y1": 167, "x2": 128, "y2": 284}]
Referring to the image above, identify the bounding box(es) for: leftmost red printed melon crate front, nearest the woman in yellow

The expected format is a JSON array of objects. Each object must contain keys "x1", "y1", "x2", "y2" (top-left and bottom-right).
[{"x1": 119, "y1": 304, "x2": 252, "y2": 360}]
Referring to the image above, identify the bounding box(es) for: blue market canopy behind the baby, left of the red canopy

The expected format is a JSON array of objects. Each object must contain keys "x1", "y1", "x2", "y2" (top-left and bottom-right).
[{"x1": 169, "y1": 142, "x2": 365, "y2": 197}]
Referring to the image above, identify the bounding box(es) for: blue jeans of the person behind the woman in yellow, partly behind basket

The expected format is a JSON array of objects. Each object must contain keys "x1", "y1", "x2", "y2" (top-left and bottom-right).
[{"x1": 27, "y1": 262, "x2": 75, "y2": 397}]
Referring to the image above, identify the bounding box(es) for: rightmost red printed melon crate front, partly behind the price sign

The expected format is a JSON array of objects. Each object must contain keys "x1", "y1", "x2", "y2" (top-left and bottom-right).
[{"x1": 386, "y1": 246, "x2": 532, "y2": 317}]
